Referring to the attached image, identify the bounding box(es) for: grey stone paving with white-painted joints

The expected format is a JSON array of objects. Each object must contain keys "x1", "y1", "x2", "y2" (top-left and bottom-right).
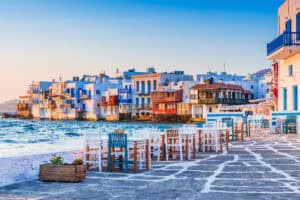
[{"x1": 0, "y1": 131, "x2": 300, "y2": 199}]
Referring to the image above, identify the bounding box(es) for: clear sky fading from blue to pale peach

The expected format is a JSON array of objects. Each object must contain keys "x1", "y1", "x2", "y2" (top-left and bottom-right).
[{"x1": 0, "y1": 0, "x2": 283, "y2": 102}]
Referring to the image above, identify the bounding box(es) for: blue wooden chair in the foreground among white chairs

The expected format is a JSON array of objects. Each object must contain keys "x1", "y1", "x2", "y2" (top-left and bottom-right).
[{"x1": 108, "y1": 133, "x2": 129, "y2": 172}]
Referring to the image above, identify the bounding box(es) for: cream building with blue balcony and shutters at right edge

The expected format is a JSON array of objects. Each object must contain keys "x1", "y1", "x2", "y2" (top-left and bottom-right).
[{"x1": 267, "y1": 0, "x2": 300, "y2": 111}]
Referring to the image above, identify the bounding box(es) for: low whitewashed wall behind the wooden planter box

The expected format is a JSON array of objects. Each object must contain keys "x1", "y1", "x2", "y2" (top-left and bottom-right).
[{"x1": 0, "y1": 150, "x2": 82, "y2": 187}]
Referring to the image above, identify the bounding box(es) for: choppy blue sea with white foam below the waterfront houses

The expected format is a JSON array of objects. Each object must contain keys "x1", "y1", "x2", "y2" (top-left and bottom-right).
[{"x1": 0, "y1": 118, "x2": 182, "y2": 157}]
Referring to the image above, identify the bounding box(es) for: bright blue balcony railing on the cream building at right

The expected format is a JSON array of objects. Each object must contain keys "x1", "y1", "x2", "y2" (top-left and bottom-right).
[{"x1": 267, "y1": 32, "x2": 300, "y2": 56}]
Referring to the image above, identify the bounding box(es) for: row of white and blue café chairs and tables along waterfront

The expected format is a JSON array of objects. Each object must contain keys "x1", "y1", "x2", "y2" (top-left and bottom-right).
[{"x1": 84, "y1": 111, "x2": 255, "y2": 172}]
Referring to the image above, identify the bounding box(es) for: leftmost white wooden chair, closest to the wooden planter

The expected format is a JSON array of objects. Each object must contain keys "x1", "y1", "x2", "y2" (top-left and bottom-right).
[{"x1": 83, "y1": 134, "x2": 103, "y2": 172}]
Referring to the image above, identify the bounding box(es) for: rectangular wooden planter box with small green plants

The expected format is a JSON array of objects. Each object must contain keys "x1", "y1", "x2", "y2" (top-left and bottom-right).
[{"x1": 40, "y1": 155, "x2": 85, "y2": 182}]
